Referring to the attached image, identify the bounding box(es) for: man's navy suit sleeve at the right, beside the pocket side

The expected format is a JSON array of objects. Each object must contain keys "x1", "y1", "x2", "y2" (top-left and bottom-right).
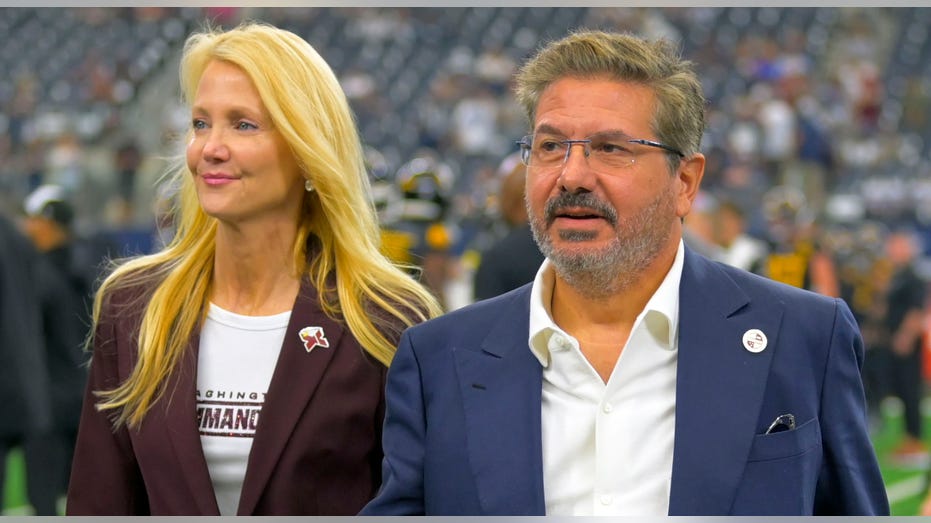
[{"x1": 814, "y1": 300, "x2": 889, "y2": 516}]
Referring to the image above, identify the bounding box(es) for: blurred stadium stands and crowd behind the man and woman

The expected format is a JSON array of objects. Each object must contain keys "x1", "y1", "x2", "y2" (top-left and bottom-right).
[{"x1": 0, "y1": 7, "x2": 931, "y2": 516}]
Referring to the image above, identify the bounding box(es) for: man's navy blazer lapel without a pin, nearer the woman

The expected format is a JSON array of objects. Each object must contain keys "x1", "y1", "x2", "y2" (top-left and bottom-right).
[{"x1": 453, "y1": 285, "x2": 546, "y2": 515}]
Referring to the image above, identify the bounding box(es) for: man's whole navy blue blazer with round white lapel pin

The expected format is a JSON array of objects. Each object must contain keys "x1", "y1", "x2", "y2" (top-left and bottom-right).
[{"x1": 362, "y1": 248, "x2": 889, "y2": 515}]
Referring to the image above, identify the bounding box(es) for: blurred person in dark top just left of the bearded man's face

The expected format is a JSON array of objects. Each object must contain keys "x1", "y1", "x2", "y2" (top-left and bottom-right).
[{"x1": 472, "y1": 153, "x2": 543, "y2": 300}]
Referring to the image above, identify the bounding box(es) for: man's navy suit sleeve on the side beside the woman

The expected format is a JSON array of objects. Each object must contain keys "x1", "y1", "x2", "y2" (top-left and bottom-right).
[{"x1": 360, "y1": 332, "x2": 426, "y2": 516}]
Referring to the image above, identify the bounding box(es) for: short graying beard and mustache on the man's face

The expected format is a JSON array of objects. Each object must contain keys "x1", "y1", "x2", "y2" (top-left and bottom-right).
[{"x1": 528, "y1": 192, "x2": 677, "y2": 300}]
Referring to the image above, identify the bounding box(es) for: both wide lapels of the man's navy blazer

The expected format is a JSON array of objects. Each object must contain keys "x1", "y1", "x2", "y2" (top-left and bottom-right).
[{"x1": 453, "y1": 247, "x2": 784, "y2": 515}]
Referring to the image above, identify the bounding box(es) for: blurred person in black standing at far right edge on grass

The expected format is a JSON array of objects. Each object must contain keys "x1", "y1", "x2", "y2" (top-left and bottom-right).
[{"x1": 885, "y1": 230, "x2": 928, "y2": 467}]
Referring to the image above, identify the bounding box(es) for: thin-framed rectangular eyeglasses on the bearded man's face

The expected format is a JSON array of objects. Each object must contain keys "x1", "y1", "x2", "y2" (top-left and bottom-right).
[{"x1": 516, "y1": 133, "x2": 685, "y2": 169}]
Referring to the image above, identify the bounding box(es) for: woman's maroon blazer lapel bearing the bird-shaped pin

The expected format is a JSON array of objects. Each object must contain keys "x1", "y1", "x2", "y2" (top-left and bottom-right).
[{"x1": 237, "y1": 280, "x2": 344, "y2": 515}]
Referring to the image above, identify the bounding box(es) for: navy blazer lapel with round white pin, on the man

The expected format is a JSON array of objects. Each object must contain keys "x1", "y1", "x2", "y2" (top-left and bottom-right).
[{"x1": 669, "y1": 250, "x2": 783, "y2": 515}]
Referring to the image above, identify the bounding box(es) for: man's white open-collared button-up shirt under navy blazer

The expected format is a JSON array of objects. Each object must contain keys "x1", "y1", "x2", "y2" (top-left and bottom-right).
[{"x1": 529, "y1": 241, "x2": 684, "y2": 516}]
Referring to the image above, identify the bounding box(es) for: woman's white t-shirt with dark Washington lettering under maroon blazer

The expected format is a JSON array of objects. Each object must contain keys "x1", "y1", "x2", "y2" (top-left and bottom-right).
[{"x1": 197, "y1": 303, "x2": 291, "y2": 516}]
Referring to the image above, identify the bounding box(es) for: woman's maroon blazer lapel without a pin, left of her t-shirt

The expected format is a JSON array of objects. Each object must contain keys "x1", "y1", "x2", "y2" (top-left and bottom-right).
[{"x1": 157, "y1": 334, "x2": 220, "y2": 516}]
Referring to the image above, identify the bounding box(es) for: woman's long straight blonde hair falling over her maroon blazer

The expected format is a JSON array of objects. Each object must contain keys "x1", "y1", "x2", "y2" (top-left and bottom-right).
[{"x1": 94, "y1": 22, "x2": 442, "y2": 426}]
